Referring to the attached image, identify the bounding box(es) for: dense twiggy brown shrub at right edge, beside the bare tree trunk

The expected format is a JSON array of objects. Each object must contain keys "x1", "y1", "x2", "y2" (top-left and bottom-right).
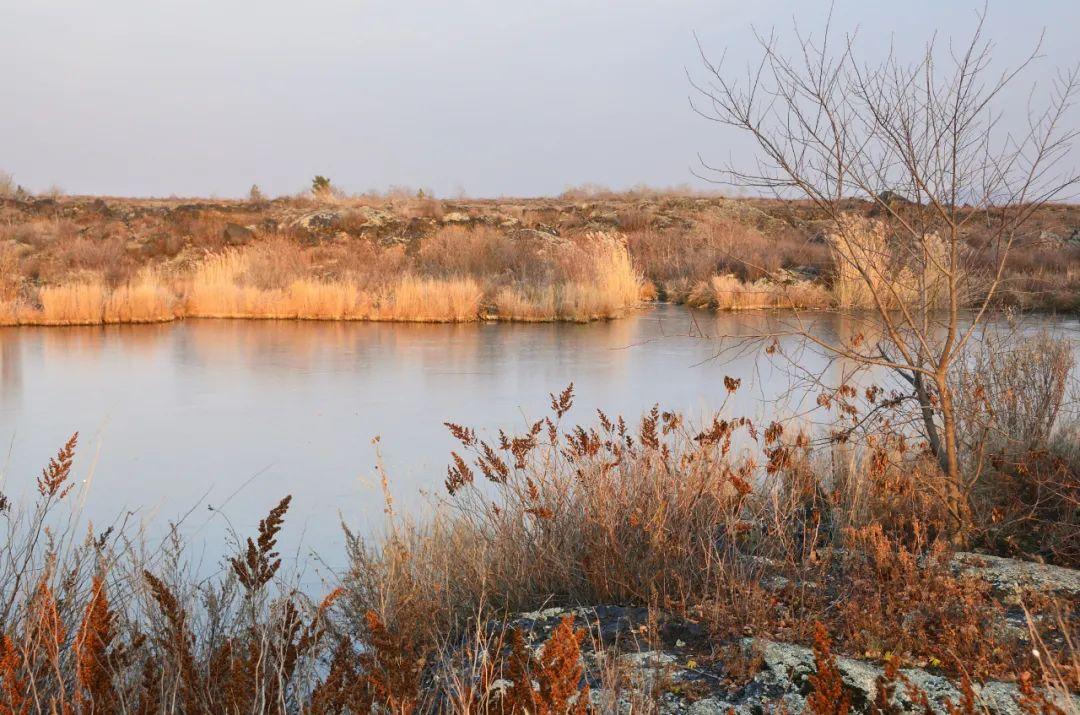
[{"x1": 956, "y1": 333, "x2": 1080, "y2": 567}]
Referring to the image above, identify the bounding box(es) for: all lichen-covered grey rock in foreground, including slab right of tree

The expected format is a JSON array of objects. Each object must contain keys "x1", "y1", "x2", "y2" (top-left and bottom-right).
[{"x1": 511, "y1": 553, "x2": 1080, "y2": 715}]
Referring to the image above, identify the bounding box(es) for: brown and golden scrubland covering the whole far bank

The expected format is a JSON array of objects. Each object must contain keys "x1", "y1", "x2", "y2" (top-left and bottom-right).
[{"x1": 0, "y1": 192, "x2": 1080, "y2": 325}]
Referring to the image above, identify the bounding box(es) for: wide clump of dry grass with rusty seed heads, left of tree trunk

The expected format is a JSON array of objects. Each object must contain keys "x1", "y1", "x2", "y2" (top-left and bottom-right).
[{"x1": 350, "y1": 392, "x2": 1076, "y2": 675}]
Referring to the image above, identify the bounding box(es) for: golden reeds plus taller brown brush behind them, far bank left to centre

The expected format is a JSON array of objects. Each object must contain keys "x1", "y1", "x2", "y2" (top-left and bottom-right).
[{"x1": 0, "y1": 228, "x2": 644, "y2": 325}]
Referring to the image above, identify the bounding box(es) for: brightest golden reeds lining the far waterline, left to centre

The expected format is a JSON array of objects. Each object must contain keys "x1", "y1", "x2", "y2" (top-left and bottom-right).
[{"x1": 0, "y1": 241, "x2": 650, "y2": 325}]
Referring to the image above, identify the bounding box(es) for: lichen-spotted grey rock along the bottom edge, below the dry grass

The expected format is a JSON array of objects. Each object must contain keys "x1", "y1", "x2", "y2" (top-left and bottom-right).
[{"x1": 479, "y1": 604, "x2": 1080, "y2": 715}]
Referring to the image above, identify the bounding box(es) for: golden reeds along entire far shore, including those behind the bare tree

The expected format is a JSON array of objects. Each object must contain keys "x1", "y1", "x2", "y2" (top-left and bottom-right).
[{"x1": 0, "y1": 218, "x2": 920, "y2": 325}]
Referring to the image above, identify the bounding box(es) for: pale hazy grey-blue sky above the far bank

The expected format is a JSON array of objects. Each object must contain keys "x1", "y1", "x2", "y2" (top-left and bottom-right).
[{"x1": 0, "y1": 0, "x2": 1080, "y2": 197}]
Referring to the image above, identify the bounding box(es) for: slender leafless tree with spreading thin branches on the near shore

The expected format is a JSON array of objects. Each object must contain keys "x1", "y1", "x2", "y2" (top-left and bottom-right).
[{"x1": 691, "y1": 13, "x2": 1080, "y2": 535}]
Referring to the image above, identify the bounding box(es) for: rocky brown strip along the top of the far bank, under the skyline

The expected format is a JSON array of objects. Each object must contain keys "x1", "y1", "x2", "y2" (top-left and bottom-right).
[{"x1": 8, "y1": 194, "x2": 1080, "y2": 254}]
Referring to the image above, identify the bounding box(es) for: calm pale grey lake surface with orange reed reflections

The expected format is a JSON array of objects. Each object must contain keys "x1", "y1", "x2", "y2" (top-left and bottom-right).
[{"x1": 0, "y1": 306, "x2": 1077, "y2": 574}]
